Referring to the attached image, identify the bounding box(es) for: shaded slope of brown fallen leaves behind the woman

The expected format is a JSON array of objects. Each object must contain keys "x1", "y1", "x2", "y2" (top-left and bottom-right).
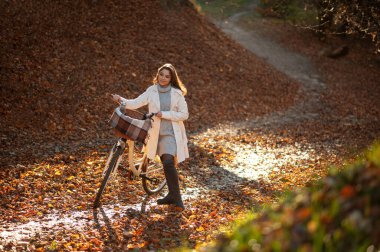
[{"x1": 0, "y1": 0, "x2": 298, "y2": 166}]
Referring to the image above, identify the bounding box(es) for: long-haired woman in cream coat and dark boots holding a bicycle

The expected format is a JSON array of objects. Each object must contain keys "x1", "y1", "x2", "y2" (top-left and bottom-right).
[{"x1": 112, "y1": 64, "x2": 189, "y2": 209}]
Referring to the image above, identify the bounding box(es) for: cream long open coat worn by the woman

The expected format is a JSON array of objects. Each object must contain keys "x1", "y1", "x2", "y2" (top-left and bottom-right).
[{"x1": 121, "y1": 84, "x2": 189, "y2": 163}]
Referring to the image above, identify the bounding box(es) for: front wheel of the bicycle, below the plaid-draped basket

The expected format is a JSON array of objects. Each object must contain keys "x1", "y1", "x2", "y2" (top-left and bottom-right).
[{"x1": 94, "y1": 144, "x2": 124, "y2": 208}]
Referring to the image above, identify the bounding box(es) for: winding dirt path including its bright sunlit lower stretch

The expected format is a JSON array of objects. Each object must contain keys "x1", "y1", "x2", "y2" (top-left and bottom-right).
[{"x1": 188, "y1": 3, "x2": 344, "y2": 188}]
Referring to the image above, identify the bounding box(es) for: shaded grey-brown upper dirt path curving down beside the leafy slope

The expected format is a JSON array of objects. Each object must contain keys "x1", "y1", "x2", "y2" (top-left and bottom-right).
[{"x1": 209, "y1": 1, "x2": 328, "y2": 132}]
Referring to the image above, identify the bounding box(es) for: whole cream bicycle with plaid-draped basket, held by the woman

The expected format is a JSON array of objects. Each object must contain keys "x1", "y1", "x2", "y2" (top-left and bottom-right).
[{"x1": 94, "y1": 102, "x2": 166, "y2": 208}]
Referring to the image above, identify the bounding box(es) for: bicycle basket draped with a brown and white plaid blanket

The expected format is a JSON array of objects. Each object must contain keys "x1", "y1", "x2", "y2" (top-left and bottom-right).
[{"x1": 110, "y1": 108, "x2": 152, "y2": 144}]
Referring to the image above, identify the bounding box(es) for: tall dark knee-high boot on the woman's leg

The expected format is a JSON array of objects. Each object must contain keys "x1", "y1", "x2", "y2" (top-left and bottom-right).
[{"x1": 157, "y1": 154, "x2": 185, "y2": 209}]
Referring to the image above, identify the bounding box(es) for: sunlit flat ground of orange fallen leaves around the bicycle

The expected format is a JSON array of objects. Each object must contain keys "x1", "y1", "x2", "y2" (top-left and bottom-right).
[{"x1": 1, "y1": 124, "x2": 348, "y2": 250}]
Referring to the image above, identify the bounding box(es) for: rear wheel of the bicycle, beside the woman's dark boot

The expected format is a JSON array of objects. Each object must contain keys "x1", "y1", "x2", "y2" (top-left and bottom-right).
[{"x1": 140, "y1": 156, "x2": 166, "y2": 195}]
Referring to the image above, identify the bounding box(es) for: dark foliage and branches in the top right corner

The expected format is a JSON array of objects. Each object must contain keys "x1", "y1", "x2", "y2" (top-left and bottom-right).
[{"x1": 260, "y1": 0, "x2": 380, "y2": 52}]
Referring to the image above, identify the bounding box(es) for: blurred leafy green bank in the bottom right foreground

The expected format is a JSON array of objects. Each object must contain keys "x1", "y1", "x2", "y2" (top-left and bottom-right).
[{"x1": 207, "y1": 145, "x2": 380, "y2": 251}]
